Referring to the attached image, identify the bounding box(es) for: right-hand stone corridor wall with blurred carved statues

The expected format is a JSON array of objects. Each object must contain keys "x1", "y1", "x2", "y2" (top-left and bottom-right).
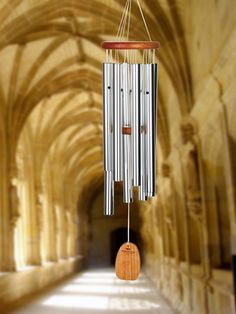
[{"x1": 140, "y1": 1, "x2": 236, "y2": 314}]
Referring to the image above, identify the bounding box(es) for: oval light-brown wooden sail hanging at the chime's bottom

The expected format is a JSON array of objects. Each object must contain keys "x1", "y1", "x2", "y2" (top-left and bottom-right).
[{"x1": 115, "y1": 242, "x2": 141, "y2": 280}]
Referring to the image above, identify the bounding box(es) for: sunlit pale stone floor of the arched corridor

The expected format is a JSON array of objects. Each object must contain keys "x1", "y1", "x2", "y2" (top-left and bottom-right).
[{"x1": 13, "y1": 269, "x2": 174, "y2": 314}]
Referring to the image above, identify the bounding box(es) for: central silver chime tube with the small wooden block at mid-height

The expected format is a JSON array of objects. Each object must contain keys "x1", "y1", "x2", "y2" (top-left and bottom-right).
[{"x1": 121, "y1": 63, "x2": 132, "y2": 203}]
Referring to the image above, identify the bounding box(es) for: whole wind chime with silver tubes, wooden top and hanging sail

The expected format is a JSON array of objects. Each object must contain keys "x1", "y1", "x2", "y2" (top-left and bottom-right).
[{"x1": 102, "y1": 0, "x2": 159, "y2": 280}]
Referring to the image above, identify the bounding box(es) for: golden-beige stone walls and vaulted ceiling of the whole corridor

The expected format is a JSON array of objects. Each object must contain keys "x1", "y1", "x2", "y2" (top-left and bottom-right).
[{"x1": 0, "y1": 0, "x2": 236, "y2": 314}]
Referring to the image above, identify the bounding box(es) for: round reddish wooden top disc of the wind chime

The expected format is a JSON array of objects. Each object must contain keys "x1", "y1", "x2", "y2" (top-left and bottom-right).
[{"x1": 102, "y1": 41, "x2": 160, "y2": 50}]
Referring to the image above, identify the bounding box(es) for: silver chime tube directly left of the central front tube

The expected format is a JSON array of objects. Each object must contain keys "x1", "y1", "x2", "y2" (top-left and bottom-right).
[{"x1": 113, "y1": 64, "x2": 123, "y2": 182}]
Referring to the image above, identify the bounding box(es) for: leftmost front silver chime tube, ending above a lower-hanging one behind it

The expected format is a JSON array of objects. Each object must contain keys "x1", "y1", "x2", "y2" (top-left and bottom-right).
[{"x1": 103, "y1": 63, "x2": 113, "y2": 171}]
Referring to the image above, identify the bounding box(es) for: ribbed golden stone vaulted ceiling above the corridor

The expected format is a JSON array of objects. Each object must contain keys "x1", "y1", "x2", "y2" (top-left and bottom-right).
[{"x1": 0, "y1": 0, "x2": 234, "y2": 204}]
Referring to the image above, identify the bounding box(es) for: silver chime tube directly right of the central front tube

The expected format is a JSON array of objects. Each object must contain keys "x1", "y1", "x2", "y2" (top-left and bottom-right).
[{"x1": 130, "y1": 64, "x2": 140, "y2": 186}]
